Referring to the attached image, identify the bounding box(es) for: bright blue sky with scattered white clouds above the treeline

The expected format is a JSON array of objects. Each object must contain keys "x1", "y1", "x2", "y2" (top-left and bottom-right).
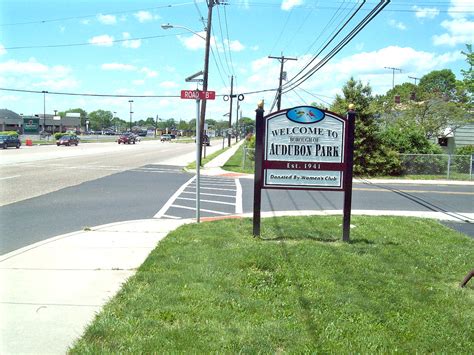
[{"x1": 0, "y1": 0, "x2": 474, "y2": 126}]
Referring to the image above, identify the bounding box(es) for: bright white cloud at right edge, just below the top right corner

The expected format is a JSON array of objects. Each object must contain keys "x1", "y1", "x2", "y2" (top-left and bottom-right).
[{"x1": 433, "y1": 18, "x2": 474, "y2": 47}]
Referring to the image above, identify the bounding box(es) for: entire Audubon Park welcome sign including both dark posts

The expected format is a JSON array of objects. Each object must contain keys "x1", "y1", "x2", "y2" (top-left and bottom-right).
[{"x1": 253, "y1": 102, "x2": 355, "y2": 241}]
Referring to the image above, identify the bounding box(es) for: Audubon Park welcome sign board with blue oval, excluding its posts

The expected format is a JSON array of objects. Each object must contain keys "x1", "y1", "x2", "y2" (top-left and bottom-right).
[{"x1": 262, "y1": 106, "x2": 347, "y2": 190}]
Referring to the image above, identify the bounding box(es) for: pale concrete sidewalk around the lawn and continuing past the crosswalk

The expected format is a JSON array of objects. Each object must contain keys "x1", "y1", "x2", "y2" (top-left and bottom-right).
[{"x1": 0, "y1": 140, "x2": 474, "y2": 354}]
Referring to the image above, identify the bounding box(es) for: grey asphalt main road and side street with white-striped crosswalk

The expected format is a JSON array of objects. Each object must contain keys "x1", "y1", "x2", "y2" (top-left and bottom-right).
[{"x1": 0, "y1": 142, "x2": 474, "y2": 254}]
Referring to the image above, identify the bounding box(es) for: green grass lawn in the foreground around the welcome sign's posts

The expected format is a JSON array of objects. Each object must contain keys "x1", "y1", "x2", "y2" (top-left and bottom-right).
[{"x1": 71, "y1": 216, "x2": 474, "y2": 354}]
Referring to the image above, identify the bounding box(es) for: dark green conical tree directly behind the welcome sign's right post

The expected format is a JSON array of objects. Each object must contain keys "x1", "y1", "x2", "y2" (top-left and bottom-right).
[{"x1": 331, "y1": 78, "x2": 398, "y2": 176}]
